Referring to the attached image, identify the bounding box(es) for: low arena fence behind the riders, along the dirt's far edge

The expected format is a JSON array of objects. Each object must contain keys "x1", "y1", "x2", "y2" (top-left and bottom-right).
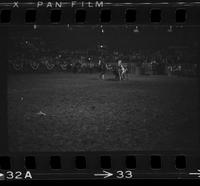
[{"x1": 8, "y1": 61, "x2": 200, "y2": 76}]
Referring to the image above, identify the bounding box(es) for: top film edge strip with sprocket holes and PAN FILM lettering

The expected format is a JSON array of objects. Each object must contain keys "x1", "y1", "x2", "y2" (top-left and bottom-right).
[{"x1": 0, "y1": 1, "x2": 200, "y2": 25}]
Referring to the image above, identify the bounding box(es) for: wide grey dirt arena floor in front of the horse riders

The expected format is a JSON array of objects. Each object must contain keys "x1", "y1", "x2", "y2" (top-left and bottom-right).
[{"x1": 8, "y1": 73, "x2": 200, "y2": 152}]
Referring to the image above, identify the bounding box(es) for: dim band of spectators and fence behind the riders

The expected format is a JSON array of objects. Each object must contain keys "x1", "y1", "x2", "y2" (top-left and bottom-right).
[{"x1": 9, "y1": 37, "x2": 199, "y2": 76}]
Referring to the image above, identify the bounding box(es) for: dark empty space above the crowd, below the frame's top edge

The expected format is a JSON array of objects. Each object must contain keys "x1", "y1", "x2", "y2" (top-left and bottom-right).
[{"x1": 9, "y1": 26, "x2": 200, "y2": 51}]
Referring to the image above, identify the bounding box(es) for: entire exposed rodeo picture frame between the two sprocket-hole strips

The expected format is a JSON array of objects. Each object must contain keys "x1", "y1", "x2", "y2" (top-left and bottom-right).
[{"x1": 7, "y1": 25, "x2": 200, "y2": 152}]
